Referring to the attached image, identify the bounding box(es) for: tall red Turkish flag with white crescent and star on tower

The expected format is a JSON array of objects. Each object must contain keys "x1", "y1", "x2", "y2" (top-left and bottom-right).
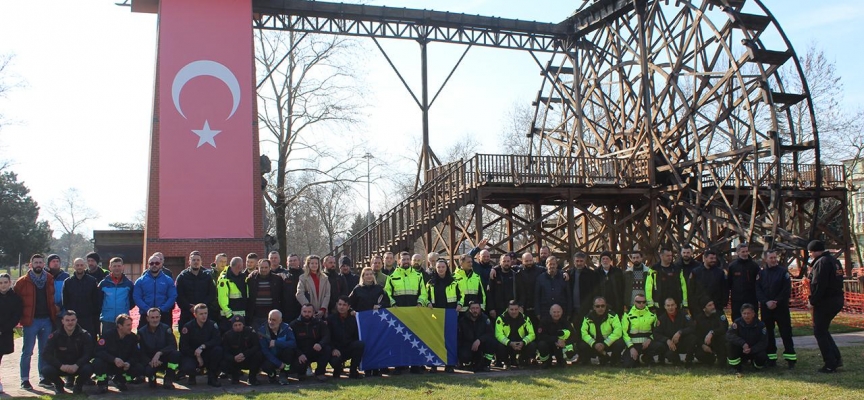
[{"x1": 151, "y1": 0, "x2": 253, "y2": 239}]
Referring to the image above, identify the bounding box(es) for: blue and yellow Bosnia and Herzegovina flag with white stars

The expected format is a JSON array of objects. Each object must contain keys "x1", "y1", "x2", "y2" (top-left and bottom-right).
[{"x1": 357, "y1": 307, "x2": 458, "y2": 370}]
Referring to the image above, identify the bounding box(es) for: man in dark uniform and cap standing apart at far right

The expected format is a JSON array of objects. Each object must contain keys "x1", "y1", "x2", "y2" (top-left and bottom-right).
[{"x1": 807, "y1": 240, "x2": 843, "y2": 373}]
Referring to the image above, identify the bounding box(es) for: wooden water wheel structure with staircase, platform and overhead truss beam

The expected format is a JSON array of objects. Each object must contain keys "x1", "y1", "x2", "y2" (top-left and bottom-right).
[{"x1": 224, "y1": 0, "x2": 851, "y2": 265}]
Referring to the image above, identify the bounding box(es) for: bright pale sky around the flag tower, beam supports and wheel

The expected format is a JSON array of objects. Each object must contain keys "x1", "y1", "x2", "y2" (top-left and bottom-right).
[{"x1": 0, "y1": 0, "x2": 864, "y2": 236}]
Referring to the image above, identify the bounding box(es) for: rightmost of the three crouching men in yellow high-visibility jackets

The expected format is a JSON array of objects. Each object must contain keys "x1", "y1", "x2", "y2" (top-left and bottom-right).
[{"x1": 621, "y1": 293, "x2": 663, "y2": 368}]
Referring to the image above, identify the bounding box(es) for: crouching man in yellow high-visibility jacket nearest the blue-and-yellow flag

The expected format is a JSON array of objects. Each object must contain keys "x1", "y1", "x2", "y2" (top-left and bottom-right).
[{"x1": 495, "y1": 300, "x2": 537, "y2": 369}]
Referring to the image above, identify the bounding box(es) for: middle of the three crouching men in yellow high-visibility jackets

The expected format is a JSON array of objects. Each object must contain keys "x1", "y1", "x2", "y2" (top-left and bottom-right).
[{"x1": 579, "y1": 297, "x2": 624, "y2": 365}]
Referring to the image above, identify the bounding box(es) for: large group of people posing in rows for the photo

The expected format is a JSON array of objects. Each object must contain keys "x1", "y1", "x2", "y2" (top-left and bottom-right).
[{"x1": 0, "y1": 240, "x2": 843, "y2": 394}]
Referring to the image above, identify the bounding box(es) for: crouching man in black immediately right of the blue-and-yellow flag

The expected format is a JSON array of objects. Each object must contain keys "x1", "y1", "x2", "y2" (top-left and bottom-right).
[{"x1": 457, "y1": 302, "x2": 503, "y2": 372}]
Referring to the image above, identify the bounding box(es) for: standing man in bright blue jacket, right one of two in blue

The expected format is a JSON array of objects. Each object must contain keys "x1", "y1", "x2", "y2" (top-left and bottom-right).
[{"x1": 133, "y1": 256, "x2": 177, "y2": 326}]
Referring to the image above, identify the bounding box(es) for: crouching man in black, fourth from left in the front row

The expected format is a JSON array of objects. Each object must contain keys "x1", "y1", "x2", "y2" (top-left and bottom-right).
[{"x1": 180, "y1": 303, "x2": 222, "y2": 387}]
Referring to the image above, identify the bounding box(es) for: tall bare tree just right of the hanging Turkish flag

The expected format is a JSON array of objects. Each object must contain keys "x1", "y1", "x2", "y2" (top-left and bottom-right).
[{"x1": 255, "y1": 30, "x2": 364, "y2": 259}]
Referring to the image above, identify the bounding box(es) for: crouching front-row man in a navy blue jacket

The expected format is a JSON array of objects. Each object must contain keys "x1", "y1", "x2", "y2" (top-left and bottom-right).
[{"x1": 258, "y1": 310, "x2": 296, "y2": 385}]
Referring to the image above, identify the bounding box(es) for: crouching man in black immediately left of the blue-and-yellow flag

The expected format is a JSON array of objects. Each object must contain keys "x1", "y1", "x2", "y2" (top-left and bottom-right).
[{"x1": 327, "y1": 296, "x2": 366, "y2": 379}]
